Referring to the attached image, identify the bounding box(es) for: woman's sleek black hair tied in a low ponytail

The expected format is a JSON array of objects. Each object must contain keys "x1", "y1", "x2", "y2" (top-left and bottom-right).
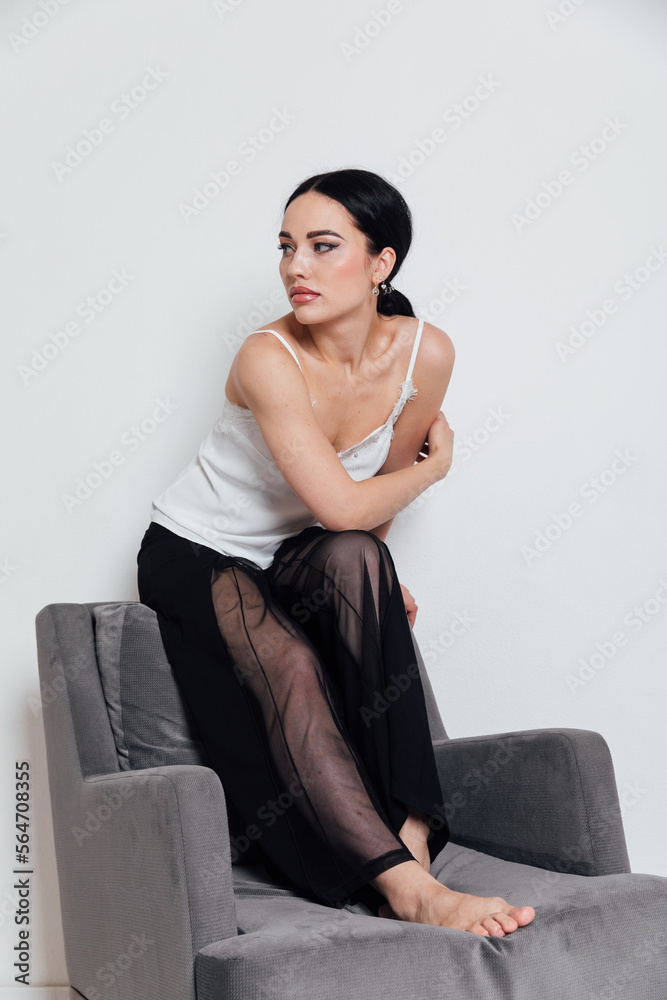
[{"x1": 285, "y1": 168, "x2": 414, "y2": 316}]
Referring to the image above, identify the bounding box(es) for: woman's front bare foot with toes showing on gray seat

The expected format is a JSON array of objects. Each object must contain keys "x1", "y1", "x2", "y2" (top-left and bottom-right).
[{"x1": 373, "y1": 861, "x2": 535, "y2": 937}]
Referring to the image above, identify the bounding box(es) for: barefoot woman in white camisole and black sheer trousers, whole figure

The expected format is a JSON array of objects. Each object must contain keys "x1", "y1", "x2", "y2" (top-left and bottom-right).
[{"x1": 138, "y1": 170, "x2": 535, "y2": 936}]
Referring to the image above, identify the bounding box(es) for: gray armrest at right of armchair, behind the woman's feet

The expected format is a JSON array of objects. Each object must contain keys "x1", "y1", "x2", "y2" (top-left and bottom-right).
[{"x1": 433, "y1": 729, "x2": 630, "y2": 875}]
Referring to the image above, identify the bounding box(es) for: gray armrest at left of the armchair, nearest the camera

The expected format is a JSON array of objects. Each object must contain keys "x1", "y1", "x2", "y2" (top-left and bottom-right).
[{"x1": 58, "y1": 765, "x2": 237, "y2": 1000}]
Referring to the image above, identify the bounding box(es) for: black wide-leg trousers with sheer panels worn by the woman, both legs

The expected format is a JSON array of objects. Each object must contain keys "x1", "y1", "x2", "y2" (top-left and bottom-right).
[{"x1": 138, "y1": 523, "x2": 449, "y2": 906}]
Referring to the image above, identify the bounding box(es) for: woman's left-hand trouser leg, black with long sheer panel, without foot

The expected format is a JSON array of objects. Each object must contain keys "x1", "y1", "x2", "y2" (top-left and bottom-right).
[{"x1": 139, "y1": 526, "x2": 412, "y2": 905}]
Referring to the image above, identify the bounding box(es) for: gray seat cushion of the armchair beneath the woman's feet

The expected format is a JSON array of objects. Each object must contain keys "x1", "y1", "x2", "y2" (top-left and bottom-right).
[{"x1": 196, "y1": 843, "x2": 667, "y2": 1000}]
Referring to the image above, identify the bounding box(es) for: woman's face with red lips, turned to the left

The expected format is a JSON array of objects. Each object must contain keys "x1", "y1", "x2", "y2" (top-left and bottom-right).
[{"x1": 280, "y1": 191, "x2": 375, "y2": 325}]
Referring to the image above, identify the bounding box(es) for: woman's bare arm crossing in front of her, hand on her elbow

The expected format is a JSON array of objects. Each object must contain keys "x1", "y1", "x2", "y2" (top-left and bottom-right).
[{"x1": 230, "y1": 333, "x2": 453, "y2": 531}]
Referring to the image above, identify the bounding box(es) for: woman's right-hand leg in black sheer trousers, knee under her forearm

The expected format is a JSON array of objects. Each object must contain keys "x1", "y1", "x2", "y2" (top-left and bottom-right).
[{"x1": 267, "y1": 527, "x2": 449, "y2": 860}]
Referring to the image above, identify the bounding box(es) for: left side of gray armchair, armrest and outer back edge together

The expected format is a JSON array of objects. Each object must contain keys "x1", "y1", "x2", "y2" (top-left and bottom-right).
[{"x1": 37, "y1": 604, "x2": 236, "y2": 1000}]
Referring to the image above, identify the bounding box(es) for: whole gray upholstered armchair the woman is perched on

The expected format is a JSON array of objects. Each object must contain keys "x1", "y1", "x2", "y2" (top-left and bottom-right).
[{"x1": 37, "y1": 602, "x2": 667, "y2": 1000}]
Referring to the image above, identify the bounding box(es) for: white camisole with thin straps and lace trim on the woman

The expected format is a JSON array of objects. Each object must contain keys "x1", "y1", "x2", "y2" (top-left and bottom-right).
[{"x1": 151, "y1": 319, "x2": 424, "y2": 569}]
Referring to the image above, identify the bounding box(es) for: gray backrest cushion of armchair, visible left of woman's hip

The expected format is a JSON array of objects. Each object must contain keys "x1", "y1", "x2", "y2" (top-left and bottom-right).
[{"x1": 94, "y1": 602, "x2": 208, "y2": 771}]
